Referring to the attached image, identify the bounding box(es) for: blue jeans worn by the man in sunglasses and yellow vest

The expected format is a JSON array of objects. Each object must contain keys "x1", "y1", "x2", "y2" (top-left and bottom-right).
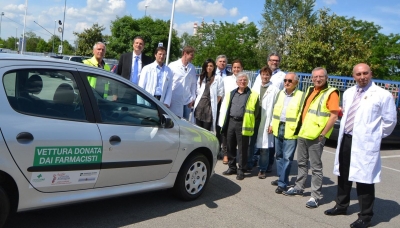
[{"x1": 275, "y1": 124, "x2": 297, "y2": 188}]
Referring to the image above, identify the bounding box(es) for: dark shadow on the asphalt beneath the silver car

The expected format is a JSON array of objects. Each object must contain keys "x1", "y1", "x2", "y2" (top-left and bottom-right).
[{"x1": 5, "y1": 174, "x2": 241, "y2": 228}]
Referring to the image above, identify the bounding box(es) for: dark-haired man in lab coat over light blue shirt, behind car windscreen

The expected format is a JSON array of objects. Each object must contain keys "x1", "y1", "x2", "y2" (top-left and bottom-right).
[{"x1": 138, "y1": 47, "x2": 173, "y2": 107}]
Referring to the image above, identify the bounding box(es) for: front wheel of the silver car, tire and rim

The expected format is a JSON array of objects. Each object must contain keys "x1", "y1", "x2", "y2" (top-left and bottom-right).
[{"x1": 173, "y1": 153, "x2": 211, "y2": 201}]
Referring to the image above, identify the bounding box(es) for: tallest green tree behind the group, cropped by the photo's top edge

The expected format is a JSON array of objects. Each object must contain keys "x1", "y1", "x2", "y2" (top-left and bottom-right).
[{"x1": 258, "y1": 0, "x2": 316, "y2": 58}]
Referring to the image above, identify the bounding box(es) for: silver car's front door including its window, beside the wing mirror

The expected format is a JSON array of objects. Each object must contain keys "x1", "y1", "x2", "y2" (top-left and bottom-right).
[{"x1": 77, "y1": 73, "x2": 179, "y2": 187}]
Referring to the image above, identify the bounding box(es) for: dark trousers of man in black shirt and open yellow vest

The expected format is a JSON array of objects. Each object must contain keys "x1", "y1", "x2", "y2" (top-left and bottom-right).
[{"x1": 226, "y1": 118, "x2": 250, "y2": 171}]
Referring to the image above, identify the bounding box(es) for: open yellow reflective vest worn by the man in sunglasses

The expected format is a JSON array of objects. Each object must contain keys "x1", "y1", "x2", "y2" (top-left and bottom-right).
[{"x1": 272, "y1": 90, "x2": 305, "y2": 139}]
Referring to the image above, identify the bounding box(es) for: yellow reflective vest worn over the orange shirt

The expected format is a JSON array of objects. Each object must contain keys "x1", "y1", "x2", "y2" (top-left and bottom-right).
[{"x1": 299, "y1": 86, "x2": 339, "y2": 140}]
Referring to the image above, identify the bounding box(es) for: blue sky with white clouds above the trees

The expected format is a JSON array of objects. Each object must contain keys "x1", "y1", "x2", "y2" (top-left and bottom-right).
[{"x1": 0, "y1": 0, "x2": 400, "y2": 43}]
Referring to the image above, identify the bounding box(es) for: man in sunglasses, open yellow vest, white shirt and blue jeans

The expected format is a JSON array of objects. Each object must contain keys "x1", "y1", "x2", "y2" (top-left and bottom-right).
[{"x1": 270, "y1": 72, "x2": 304, "y2": 194}]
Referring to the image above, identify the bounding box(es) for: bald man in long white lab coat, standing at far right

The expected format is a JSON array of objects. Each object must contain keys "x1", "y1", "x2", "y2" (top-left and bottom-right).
[{"x1": 325, "y1": 63, "x2": 397, "y2": 228}]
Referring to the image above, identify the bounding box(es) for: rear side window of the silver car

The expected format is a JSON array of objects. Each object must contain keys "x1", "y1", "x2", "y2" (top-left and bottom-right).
[{"x1": 3, "y1": 69, "x2": 86, "y2": 120}]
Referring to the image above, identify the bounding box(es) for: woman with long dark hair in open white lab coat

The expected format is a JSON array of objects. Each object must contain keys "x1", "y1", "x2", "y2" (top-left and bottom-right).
[{"x1": 192, "y1": 59, "x2": 224, "y2": 132}]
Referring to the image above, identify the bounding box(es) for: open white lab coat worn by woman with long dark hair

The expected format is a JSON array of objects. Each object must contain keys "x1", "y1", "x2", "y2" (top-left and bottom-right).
[{"x1": 192, "y1": 75, "x2": 224, "y2": 133}]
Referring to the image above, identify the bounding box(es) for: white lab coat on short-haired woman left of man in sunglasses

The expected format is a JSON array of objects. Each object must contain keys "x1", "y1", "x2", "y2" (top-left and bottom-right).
[{"x1": 252, "y1": 80, "x2": 280, "y2": 149}]
